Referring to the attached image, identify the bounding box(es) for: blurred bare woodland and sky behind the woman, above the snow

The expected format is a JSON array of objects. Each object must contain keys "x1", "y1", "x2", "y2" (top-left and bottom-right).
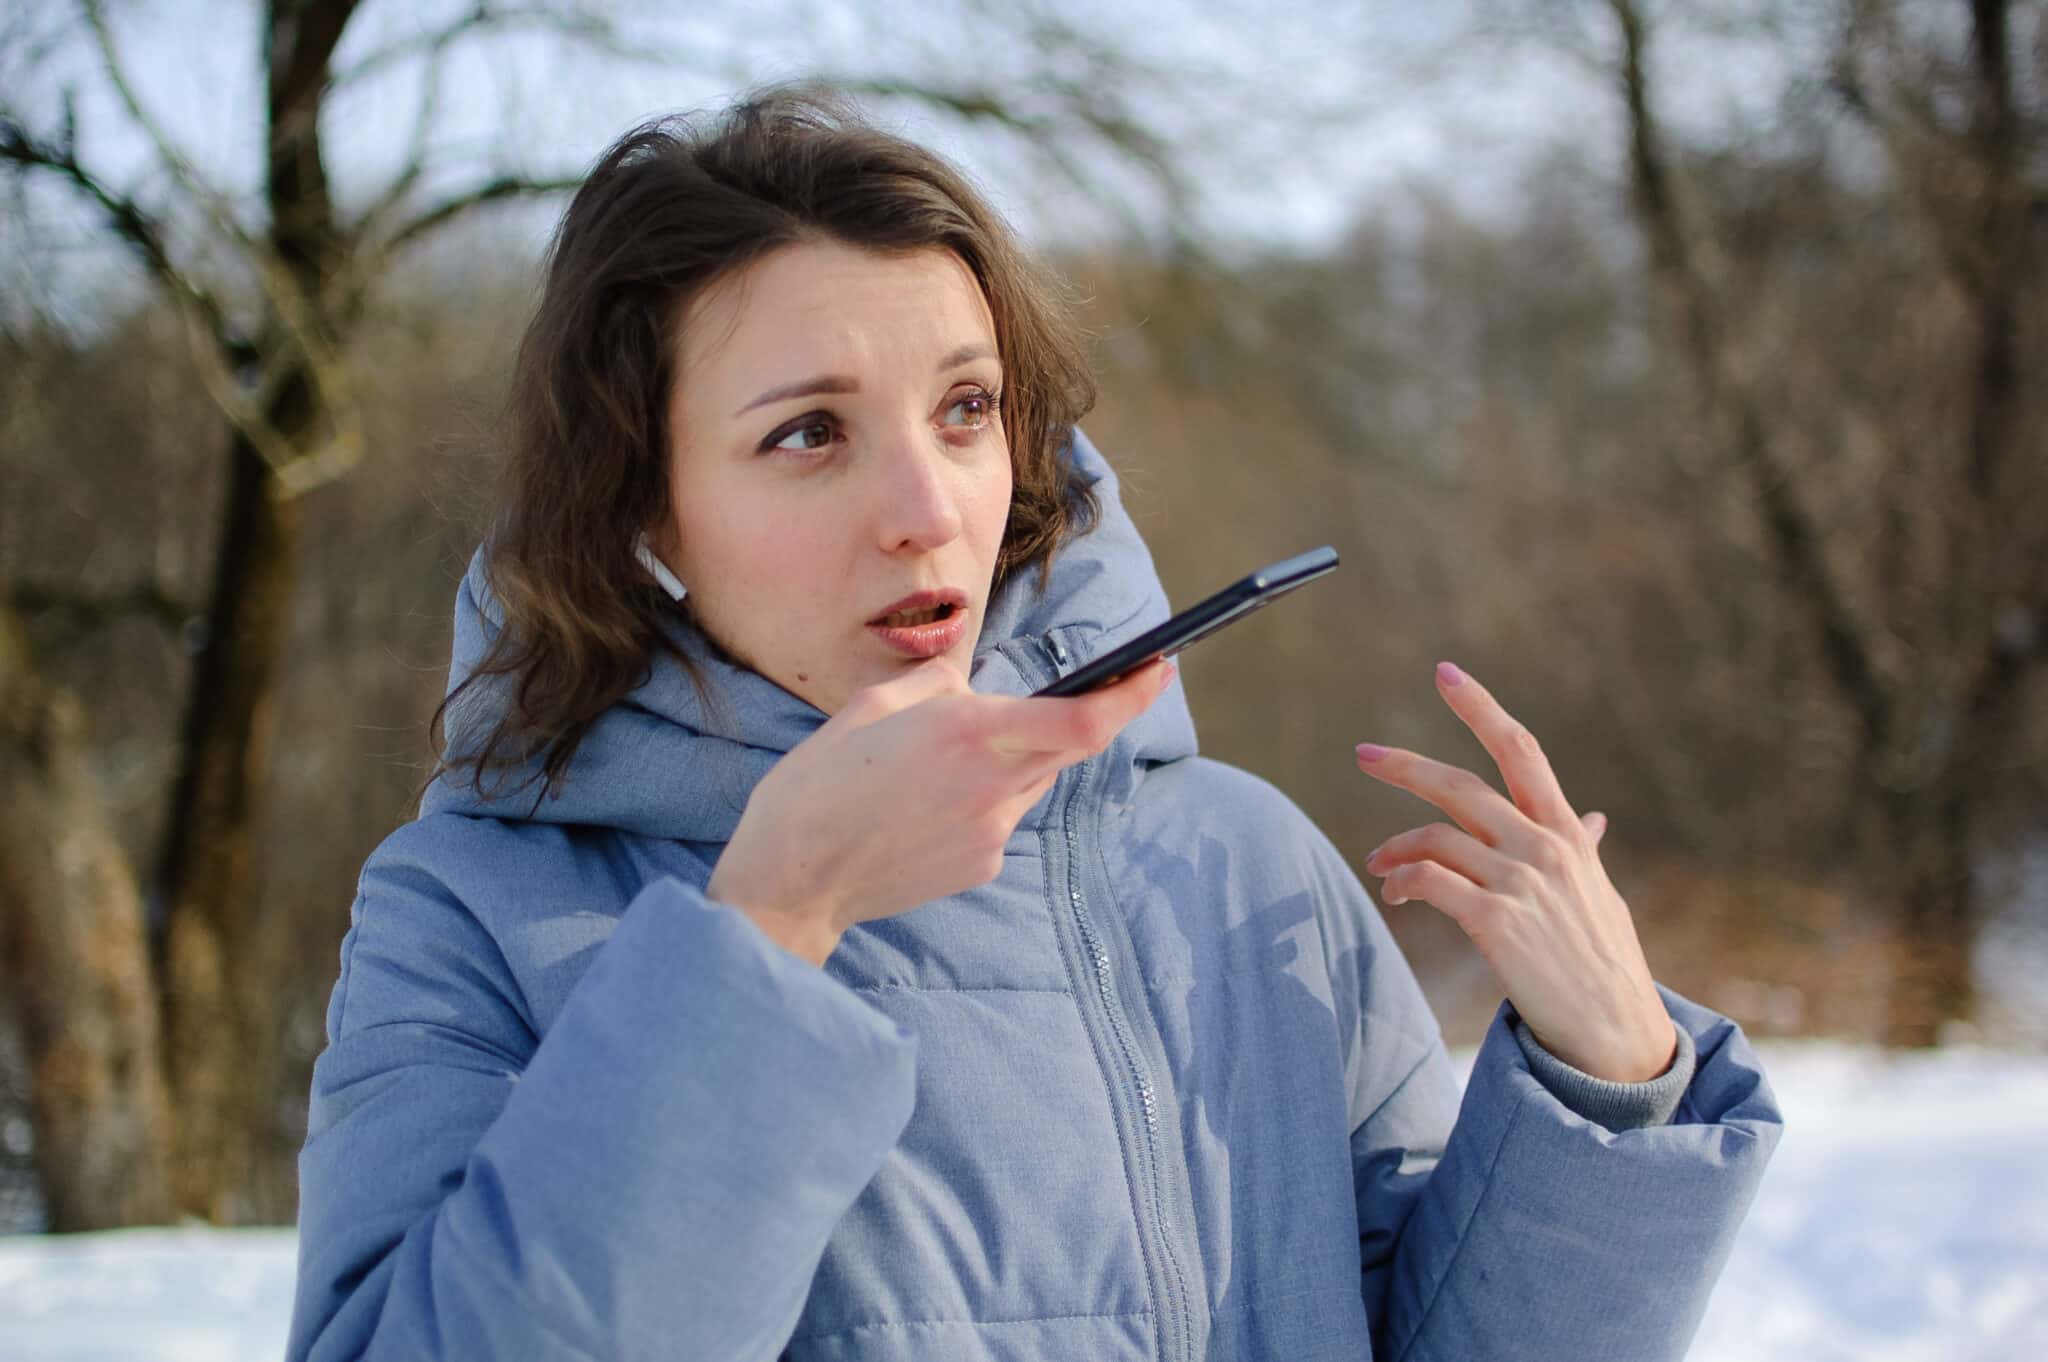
[{"x1": 0, "y1": 0, "x2": 2048, "y2": 1229}]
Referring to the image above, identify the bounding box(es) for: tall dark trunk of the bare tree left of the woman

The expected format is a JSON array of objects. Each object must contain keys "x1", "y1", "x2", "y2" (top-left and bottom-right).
[{"x1": 158, "y1": 0, "x2": 356, "y2": 1223}]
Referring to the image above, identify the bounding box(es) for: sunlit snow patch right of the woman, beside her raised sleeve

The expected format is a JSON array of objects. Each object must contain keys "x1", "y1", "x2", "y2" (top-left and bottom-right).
[{"x1": 1692, "y1": 1042, "x2": 2048, "y2": 1362}]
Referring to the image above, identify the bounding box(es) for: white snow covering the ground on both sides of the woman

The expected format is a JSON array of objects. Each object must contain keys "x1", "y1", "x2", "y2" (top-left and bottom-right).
[{"x1": 0, "y1": 1042, "x2": 2048, "y2": 1362}]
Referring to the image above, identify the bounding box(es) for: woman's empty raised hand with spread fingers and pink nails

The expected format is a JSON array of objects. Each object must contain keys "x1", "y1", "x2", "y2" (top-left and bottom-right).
[{"x1": 1358, "y1": 662, "x2": 1677, "y2": 1083}]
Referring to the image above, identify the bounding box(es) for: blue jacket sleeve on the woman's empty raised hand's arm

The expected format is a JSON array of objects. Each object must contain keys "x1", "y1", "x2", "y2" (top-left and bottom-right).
[{"x1": 1352, "y1": 962, "x2": 1784, "y2": 1362}]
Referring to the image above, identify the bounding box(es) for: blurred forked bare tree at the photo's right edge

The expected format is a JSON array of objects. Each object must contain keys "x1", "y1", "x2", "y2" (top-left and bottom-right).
[{"x1": 1606, "y1": 0, "x2": 2048, "y2": 1045}]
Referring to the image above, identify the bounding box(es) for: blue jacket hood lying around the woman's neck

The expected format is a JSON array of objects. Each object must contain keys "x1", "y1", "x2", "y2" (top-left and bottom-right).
[{"x1": 420, "y1": 430, "x2": 1196, "y2": 842}]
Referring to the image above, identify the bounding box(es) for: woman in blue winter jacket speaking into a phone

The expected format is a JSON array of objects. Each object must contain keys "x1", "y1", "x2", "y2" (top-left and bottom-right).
[{"x1": 289, "y1": 92, "x2": 1780, "y2": 1362}]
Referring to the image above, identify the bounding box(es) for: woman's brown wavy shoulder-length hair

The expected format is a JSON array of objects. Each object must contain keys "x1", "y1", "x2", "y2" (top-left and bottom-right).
[{"x1": 414, "y1": 84, "x2": 1100, "y2": 809}]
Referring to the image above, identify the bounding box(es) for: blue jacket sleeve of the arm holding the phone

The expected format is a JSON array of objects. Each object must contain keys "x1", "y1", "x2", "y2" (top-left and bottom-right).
[{"x1": 287, "y1": 843, "x2": 915, "y2": 1362}]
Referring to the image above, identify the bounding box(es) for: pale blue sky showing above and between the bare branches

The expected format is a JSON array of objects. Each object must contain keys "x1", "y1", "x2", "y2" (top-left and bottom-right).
[{"x1": 0, "y1": 0, "x2": 1826, "y2": 323}]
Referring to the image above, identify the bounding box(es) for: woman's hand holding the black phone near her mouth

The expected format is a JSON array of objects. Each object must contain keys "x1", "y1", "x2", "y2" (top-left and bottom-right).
[{"x1": 705, "y1": 659, "x2": 1174, "y2": 965}]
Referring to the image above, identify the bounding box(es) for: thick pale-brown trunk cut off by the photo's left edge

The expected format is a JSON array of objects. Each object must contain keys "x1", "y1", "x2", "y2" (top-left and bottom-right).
[{"x1": 0, "y1": 604, "x2": 172, "y2": 1231}]
